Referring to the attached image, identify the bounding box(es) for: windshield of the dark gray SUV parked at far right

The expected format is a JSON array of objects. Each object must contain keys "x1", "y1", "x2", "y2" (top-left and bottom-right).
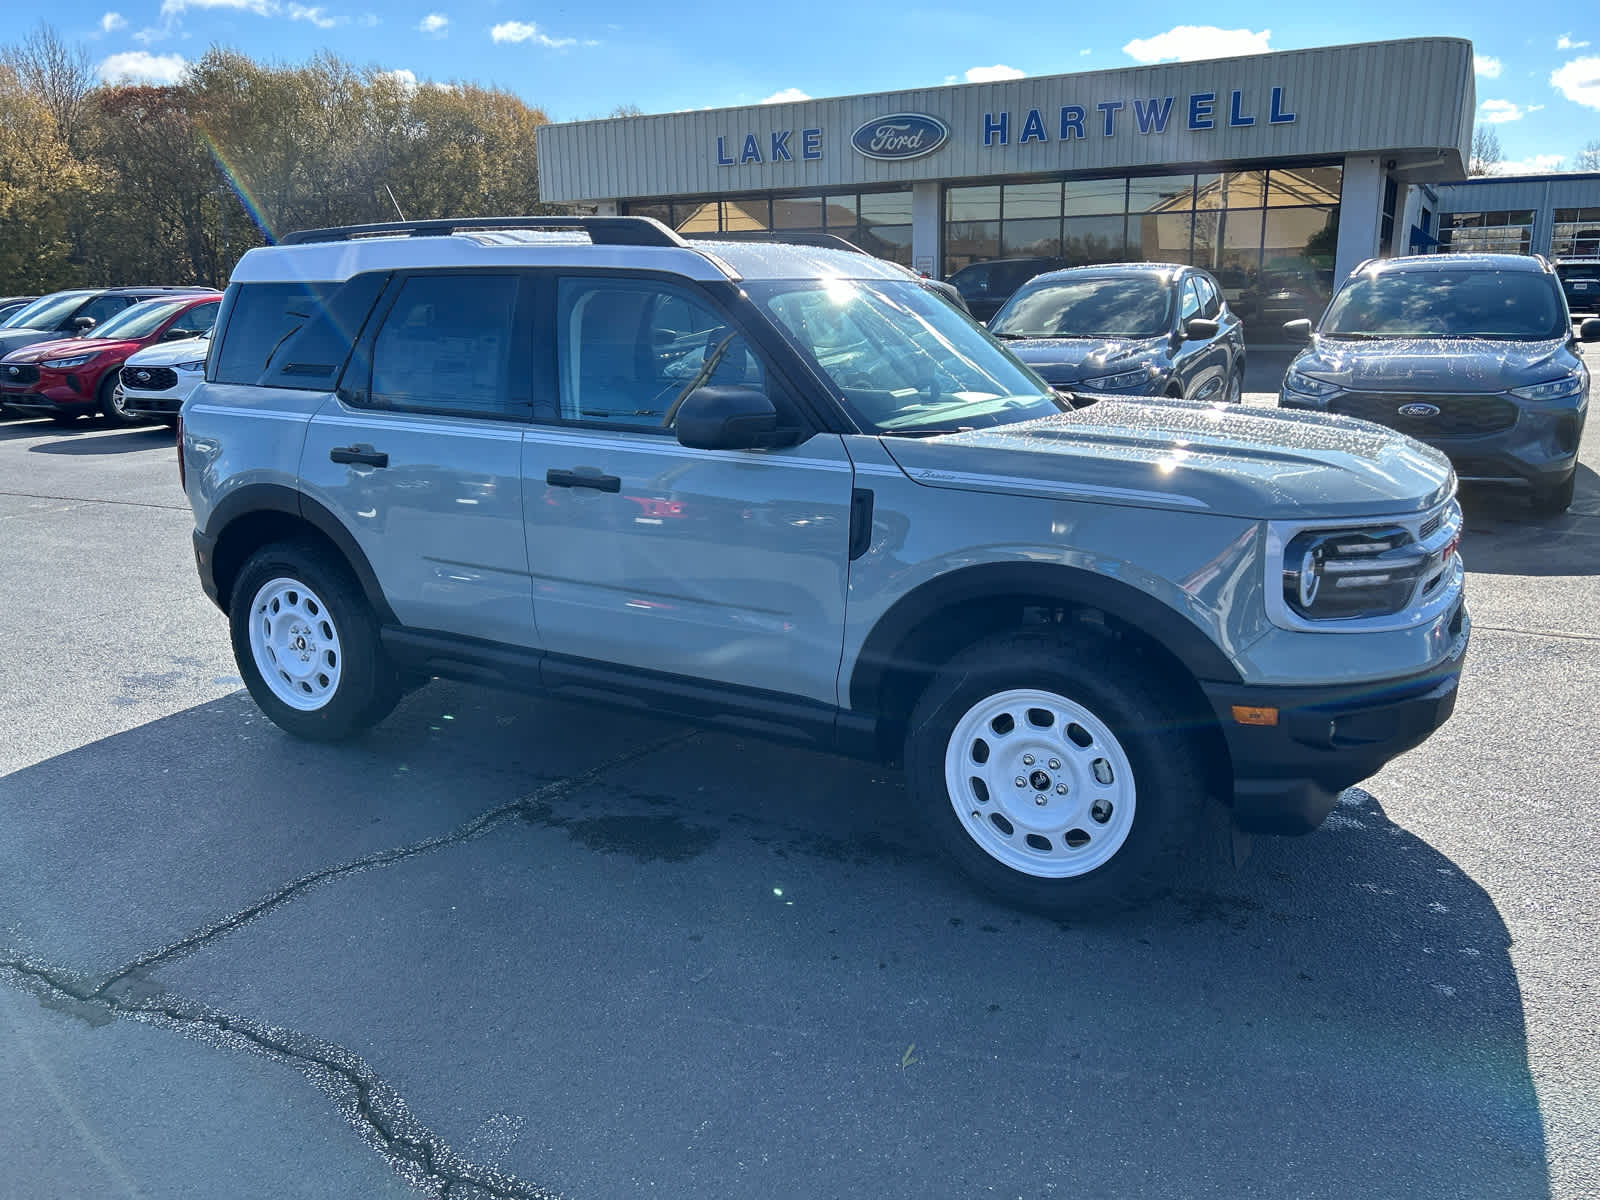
[{"x1": 1318, "y1": 267, "x2": 1566, "y2": 339}]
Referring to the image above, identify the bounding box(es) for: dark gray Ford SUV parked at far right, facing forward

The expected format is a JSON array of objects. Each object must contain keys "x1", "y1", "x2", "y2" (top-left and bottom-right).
[{"x1": 1278, "y1": 254, "x2": 1600, "y2": 515}]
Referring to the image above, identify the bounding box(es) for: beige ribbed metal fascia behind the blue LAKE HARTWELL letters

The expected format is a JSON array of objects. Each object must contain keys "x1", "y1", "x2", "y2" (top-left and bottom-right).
[{"x1": 539, "y1": 38, "x2": 1474, "y2": 202}]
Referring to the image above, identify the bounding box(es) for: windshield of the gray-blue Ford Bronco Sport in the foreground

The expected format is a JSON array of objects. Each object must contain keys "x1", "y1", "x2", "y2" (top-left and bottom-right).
[{"x1": 747, "y1": 280, "x2": 1066, "y2": 434}]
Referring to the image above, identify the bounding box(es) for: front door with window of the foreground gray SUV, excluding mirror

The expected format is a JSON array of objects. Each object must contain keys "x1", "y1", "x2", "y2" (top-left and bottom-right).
[{"x1": 523, "y1": 274, "x2": 853, "y2": 704}]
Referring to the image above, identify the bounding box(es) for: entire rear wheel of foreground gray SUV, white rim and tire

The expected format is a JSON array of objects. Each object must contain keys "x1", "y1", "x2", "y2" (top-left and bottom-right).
[{"x1": 229, "y1": 542, "x2": 402, "y2": 741}]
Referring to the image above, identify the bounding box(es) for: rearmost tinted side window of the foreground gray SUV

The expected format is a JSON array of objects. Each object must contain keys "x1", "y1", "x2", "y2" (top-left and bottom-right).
[{"x1": 211, "y1": 274, "x2": 387, "y2": 389}]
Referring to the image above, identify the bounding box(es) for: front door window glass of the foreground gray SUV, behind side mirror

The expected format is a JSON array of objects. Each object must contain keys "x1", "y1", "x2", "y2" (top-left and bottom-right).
[{"x1": 555, "y1": 278, "x2": 766, "y2": 434}]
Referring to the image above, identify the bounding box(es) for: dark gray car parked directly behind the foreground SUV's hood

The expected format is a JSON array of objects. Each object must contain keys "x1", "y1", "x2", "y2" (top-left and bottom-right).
[{"x1": 989, "y1": 262, "x2": 1245, "y2": 403}]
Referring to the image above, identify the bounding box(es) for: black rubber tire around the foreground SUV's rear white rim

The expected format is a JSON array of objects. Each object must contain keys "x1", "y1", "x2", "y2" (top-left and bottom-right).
[{"x1": 229, "y1": 542, "x2": 402, "y2": 742}]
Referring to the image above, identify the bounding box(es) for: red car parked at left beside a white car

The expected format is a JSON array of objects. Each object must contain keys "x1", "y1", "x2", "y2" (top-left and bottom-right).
[{"x1": 0, "y1": 293, "x2": 222, "y2": 426}]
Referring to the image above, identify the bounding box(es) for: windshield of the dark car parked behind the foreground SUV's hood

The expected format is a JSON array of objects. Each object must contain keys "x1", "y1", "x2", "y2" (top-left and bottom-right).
[{"x1": 989, "y1": 275, "x2": 1173, "y2": 338}]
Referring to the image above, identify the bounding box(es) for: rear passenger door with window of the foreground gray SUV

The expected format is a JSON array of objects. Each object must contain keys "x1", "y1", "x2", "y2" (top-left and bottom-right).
[{"x1": 300, "y1": 270, "x2": 538, "y2": 646}]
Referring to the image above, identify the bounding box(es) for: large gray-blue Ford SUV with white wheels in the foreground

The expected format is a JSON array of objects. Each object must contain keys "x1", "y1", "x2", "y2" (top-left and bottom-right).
[{"x1": 179, "y1": 218, "x2": 1469, "y2": 910}]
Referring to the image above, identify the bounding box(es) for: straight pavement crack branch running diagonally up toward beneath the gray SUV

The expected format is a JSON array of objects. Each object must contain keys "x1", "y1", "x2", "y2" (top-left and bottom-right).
[{"x1": 86, "y1": 730, "x2": 699, "y2": 1000}]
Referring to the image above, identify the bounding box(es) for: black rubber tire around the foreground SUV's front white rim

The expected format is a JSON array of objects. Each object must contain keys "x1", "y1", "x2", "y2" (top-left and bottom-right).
[{"x1": 906, "y1": 629, "x2": 1208, "y2": 915}]
